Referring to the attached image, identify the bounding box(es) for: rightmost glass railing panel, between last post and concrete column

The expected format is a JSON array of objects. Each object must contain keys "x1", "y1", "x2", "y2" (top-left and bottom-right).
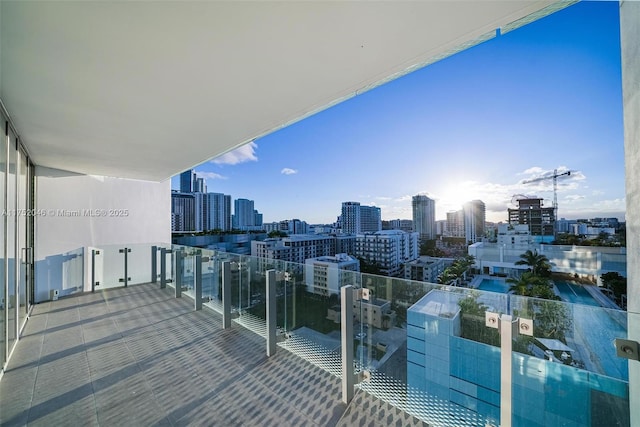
[{"x1": 511, "y1": 296, "x2": 630, "y2": 426}]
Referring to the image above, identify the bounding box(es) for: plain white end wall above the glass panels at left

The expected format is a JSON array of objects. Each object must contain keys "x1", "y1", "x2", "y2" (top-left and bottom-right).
[{"x1": 35, "y1": 166, "x2": 171, "y2": 302}]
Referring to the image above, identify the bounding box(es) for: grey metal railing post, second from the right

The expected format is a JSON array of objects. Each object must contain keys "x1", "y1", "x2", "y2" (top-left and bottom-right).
[{"x1": 340, "y1": 285, "x2": 355, "y2": 404}]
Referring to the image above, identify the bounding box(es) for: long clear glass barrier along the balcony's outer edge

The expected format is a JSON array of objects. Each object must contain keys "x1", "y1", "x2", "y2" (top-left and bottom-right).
[{"x1": 76, "y1": 245, "x2": 629, "y2": 426}]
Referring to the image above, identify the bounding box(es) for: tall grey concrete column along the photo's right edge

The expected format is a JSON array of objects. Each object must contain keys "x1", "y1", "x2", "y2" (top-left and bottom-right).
[{"x1": 620, "y1": 1, "x2": 640, "y2": 426}]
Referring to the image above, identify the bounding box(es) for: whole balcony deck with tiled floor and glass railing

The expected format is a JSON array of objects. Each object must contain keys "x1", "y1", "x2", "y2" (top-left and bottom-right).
[{"x1": 0, "y1": 245, "x2": 629, "y2": 426}]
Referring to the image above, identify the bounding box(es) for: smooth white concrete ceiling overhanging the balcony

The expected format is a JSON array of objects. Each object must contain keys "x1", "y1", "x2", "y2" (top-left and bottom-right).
[{"x1": 0, "y1": 1, "x2": 566, "y2": 181}]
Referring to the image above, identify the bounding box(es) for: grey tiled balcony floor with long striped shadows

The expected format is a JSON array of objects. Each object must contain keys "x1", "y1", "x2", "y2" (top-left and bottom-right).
[{"x1": 0, "y1": 284, "x2": 425, "y2": 426}]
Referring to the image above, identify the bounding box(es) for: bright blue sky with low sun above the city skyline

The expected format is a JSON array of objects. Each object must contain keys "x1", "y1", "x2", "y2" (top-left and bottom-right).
[{"x1": 172, "y1": 2, "x2": 625, "y2": 223}]
